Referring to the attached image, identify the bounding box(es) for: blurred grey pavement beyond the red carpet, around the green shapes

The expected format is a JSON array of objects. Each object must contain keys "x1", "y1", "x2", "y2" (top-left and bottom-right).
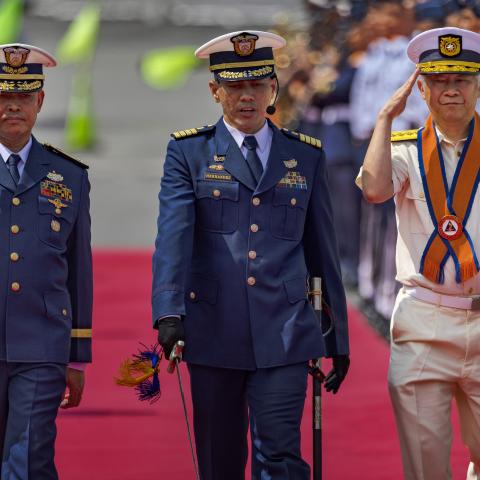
[{"x1": 25, "y1": 19, "x2": 236, "y2": 247}]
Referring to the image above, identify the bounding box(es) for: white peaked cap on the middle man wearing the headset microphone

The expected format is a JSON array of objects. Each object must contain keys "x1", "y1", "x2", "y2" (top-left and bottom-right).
[{"x1": 195, "y1": 30, "x2": 286, "y2": 81}]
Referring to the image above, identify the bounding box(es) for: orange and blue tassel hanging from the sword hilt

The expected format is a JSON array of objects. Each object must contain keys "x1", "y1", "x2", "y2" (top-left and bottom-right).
[{"x1": 115, "y1": 344, "x2": 162, "y2": 403}]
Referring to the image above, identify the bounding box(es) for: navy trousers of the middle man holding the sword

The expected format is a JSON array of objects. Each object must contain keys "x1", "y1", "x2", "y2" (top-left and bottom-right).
[{"x1": 188, "y1": 363, "x2": 310, "y2": 480}]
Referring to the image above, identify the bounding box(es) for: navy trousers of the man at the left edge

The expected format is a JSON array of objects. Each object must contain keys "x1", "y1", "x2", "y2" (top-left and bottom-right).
[{"x1": 0, "y1": 361, "x2": 66, "y2": 480}]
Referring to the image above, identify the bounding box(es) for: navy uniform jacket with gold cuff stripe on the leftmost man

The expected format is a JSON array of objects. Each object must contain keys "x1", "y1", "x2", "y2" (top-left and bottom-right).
[{"x1": 0, "y1": 139, "x2": 92, "y2": 364}]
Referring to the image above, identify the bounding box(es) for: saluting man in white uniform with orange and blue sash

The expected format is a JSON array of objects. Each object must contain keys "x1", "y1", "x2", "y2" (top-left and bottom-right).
[{"x1": 357, "y1": 28, "x2": 480, "y2": 480}]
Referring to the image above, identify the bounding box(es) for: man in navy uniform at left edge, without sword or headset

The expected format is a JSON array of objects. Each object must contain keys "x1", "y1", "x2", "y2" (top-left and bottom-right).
[{"x1": 0, "y1": 44, "x2": 92, "y2": 480}]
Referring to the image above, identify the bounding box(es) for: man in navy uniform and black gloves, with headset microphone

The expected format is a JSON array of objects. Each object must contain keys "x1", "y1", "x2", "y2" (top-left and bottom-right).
[{"x1": 152, "y1": 31, "x2": 349, "y2": 480}]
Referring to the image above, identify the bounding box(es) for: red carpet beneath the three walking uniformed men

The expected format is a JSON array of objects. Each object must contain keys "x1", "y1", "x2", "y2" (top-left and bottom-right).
[{"x1": 56, "y1": 251, "x2": 467, "y2": 480}]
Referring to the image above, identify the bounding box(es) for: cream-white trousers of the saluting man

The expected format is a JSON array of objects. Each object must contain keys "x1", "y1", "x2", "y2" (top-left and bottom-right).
[{"x1": 388, "y1": 289, "x2": 480, "y2": 480}]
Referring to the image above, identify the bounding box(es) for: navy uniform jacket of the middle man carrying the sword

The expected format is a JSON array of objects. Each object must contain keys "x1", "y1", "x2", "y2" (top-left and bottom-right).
[{"x1": 152, "y1": 119, "x2": 348, "y2": 369}]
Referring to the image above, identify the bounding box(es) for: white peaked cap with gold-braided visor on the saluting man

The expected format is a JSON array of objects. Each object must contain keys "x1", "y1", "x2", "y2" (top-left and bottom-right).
[{"x1": 407, "y1": 27, "x2": 480, "y2": 75}]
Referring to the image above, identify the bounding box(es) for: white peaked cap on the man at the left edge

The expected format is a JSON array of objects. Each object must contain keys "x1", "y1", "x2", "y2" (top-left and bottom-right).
[{"x1": 0, "y1": 43, "x2": 57, "y2": 93}]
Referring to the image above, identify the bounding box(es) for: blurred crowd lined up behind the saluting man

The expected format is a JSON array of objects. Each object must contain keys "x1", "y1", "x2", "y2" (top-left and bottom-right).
[{"x1": 276, "y1": 0, "x2": 480, "y2": 323}]
